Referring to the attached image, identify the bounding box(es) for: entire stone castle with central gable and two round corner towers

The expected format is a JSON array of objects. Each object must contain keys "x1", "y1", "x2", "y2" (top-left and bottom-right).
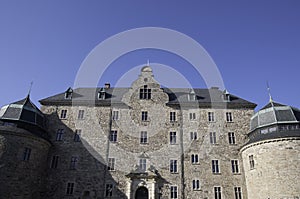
[{"x1": 0, "y1": 66, "x2": 300, "y2": 199}]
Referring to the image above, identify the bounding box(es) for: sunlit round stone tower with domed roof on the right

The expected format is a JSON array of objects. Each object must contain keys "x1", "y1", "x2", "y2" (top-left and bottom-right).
[{"x1": 241, "y1": 100, "x2": 300, "y2": 199}]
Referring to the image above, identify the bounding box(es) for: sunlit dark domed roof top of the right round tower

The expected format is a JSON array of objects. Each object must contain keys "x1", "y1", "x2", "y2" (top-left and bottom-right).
[{"x1": 250, "y1": 101, "x2": 300, "y2": 131}]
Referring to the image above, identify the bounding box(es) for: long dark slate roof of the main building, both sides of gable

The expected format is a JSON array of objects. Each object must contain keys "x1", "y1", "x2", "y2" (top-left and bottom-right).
[{"x1": 40, "y1": 88, "x2": 256, "y2": 109}]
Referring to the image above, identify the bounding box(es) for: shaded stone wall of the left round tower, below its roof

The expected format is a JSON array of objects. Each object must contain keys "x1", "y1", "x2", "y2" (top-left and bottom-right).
[{"x1": 0, "y1": 126, "x2": 50, "y2": 199}]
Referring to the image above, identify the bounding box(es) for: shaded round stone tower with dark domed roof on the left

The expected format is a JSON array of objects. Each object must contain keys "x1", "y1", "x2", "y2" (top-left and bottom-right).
[{"x1": 0, "y1": 95, "x2": 50, "y2": 199}]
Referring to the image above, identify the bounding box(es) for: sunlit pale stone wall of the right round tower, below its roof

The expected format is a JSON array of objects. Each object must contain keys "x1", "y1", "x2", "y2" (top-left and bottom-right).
[{"x1": 242, "y1": 138, "x2": 300, "y2": 199}]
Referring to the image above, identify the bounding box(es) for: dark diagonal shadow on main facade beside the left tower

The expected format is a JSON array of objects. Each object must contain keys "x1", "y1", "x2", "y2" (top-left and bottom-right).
[{"x1": 41, "y1": 112, "x2": 127, "y2": 199}]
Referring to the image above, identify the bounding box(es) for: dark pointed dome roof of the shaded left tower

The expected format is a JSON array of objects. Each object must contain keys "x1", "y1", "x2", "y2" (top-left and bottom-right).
[{"x1": 0, "y1": 95, "x2": 44, "y2": 127}]
